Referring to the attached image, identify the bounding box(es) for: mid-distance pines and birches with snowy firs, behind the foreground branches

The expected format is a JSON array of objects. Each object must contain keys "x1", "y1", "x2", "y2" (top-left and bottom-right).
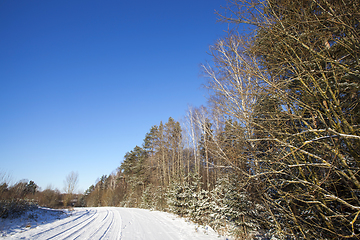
[{"x1": 84, "y1": 115, "x2": 262, "y2": 236}]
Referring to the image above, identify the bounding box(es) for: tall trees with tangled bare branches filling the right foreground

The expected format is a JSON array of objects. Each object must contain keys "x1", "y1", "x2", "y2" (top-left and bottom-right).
[{"x1": 204, "y1": 0, "x2": 360, "y2": 238}]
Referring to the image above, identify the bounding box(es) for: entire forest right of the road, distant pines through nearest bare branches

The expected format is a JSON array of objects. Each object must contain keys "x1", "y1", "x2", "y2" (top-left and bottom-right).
[{"x1": 85, "y1": 0, "x2": 360, "y2": 239}]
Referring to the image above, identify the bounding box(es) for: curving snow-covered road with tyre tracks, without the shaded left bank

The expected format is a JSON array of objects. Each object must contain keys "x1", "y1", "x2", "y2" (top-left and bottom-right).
[{"x1": 5, "y1": 207, "x2": 225, "y2": 240}]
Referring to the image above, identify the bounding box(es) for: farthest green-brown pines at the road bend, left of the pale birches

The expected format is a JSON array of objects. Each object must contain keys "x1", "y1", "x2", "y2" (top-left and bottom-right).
[{"x1": 86, "y1": 118, "x2": 186, "y2": 209}]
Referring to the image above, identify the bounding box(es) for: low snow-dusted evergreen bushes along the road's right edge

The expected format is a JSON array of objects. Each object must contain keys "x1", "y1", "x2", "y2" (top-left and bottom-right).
[{"x1": 167, "y1": 172, "x2": 261, "y2": 237}]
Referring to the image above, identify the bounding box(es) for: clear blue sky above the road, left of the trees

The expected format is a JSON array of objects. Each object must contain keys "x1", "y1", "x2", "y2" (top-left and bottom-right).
[{"x1": 0, "y1": 0, "x2": 227, "y2": 191}]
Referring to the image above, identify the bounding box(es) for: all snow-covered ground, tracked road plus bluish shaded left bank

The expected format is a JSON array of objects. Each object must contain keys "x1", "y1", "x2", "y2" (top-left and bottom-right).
[{"x1": 0, "y1": 207, "x2": 226, "y2": 240}]
